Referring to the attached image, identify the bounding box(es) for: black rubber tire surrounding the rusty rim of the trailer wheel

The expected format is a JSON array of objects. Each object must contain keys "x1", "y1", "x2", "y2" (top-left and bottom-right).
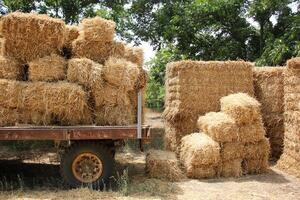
[{"x1": 60, "y1": 142, "x2": 115, "y2": 190}]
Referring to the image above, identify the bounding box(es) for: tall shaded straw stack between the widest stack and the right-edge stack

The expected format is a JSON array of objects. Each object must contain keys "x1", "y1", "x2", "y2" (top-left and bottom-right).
[{"x1": 254, "y1": 67, "x2": 285, "y2": 159}]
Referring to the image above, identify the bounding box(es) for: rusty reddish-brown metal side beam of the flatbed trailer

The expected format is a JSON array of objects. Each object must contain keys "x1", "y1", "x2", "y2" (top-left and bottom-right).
[{"x1": 0, "y1": 126, "x2": 150, "y2": 141}]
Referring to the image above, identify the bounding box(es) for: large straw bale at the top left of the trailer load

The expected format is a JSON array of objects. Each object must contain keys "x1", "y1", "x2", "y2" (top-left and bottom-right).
[{"x1": 0, "y1": 12, "x2": 65, "y2": 64}]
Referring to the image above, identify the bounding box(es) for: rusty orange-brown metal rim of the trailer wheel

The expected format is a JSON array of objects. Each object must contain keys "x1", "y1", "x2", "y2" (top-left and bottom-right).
[{"x1": 72, "y1": 153, "x2": 103, "y2": 183}]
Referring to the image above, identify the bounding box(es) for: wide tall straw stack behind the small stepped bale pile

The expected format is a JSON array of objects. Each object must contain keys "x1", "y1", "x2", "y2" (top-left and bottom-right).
[{"x1": 163, "y1": 61, "x2": 254, "y2": 151}]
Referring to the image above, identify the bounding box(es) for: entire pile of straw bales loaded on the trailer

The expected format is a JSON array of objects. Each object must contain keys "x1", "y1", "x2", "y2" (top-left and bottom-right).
[{"x1": 0, "y1": 12, "x2": 146, "y2": 126}]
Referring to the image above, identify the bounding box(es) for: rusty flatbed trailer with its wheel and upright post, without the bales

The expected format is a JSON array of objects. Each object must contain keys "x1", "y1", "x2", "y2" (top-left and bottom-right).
[{"x1": 0, "y1": 92, "x2": 150, "y2": 189}]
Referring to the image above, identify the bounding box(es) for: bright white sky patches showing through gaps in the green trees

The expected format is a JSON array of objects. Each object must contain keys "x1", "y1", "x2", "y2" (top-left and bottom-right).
[{"x1": 141, "y1": 2, "x2": 297, "y2": 62}]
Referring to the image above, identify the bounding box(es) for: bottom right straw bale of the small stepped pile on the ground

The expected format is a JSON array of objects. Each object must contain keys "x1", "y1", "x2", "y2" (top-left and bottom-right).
[{"x1": 242, "y1": 156, "x2": 269, "y2": 174}]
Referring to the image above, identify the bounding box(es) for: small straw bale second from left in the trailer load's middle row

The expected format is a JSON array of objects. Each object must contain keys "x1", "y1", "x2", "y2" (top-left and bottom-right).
[{"x1": 28, "y1": 54, "x2": 67, "y2": 82}]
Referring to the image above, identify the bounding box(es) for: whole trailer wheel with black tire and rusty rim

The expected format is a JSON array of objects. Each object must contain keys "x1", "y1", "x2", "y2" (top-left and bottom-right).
[{"x1": 60, "y1": 142, "x2": 114, "y2": 189}]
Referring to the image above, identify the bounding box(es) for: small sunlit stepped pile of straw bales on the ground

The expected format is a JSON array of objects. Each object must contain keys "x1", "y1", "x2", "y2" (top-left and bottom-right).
[{"x1": 180, "y1": 93, "x2": 270, "y2": 178}]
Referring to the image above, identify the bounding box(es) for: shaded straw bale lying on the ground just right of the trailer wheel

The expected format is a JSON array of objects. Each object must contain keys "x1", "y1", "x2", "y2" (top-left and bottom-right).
[{"x1": 146, "y1": 150, "x2": 184, "y2": 181}]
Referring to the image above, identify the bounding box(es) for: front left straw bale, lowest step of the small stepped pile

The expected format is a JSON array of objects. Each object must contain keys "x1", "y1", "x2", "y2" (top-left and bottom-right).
[{"x1": 179, "y1": 133, "x2": 220, "y2": 178}]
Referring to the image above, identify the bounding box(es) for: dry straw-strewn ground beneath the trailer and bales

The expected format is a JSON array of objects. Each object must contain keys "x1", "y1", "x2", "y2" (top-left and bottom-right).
[{"x1": 0, "y1": 112, "x2": 300, "y2": 200}]
